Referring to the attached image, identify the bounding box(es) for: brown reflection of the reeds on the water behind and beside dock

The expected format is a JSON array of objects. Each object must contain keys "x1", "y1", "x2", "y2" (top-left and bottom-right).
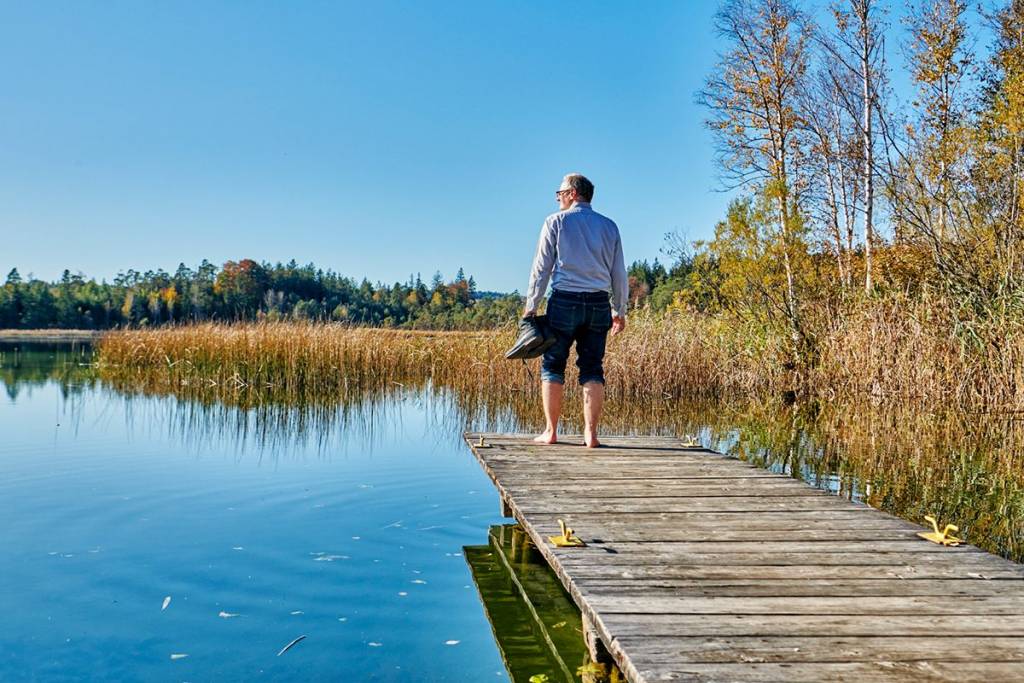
[{"x1": 6, "y1": 345, "x2": 1024, "y2": 561}]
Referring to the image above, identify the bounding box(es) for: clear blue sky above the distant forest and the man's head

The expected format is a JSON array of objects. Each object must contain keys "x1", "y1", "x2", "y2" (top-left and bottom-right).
[{"x1": 0, "y1": 0, "x2": 929, "y2": 291}]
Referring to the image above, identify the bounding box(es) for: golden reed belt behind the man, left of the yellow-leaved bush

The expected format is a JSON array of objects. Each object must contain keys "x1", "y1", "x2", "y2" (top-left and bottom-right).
[{"x1": 98, "y1": 313, "x2": 766, "y2": 399}]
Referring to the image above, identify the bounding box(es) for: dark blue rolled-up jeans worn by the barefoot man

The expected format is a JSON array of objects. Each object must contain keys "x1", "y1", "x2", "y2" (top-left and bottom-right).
[{"x1": 541, "y1": 290, "x2": 611, "y2": 384}]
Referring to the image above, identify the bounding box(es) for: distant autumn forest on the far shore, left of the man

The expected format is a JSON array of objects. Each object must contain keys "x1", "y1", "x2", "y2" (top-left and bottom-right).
[{"x1": 0, "y1": 259, "x2": 522, "y2": 330}]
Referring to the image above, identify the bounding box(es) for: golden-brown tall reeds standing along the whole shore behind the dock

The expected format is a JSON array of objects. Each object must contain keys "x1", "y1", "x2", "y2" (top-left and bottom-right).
[{"x1": 98, "y1": 296, "x2": 1024, "y2": 412}]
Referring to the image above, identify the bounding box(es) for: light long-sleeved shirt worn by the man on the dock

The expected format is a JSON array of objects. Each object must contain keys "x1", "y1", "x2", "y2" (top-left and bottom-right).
[{"x1": 526, "y1": 202, "x2": 629, "y2": 315}]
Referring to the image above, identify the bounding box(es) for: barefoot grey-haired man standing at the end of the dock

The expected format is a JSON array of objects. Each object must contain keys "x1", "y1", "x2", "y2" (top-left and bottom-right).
[{"x1": 523, "y1": 173, "x2": 628, "y2": 449}]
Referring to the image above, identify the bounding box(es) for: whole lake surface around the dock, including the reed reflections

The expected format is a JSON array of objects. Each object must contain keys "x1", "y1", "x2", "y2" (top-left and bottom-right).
[{"x1": 0, "y1": 343, "x2": 1024, "y2": 681}]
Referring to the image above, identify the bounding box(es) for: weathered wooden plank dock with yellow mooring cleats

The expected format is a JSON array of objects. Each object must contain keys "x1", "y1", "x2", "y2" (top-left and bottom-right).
[{"x1": 466, "y1": 433, "x2": 1024, "y2": 683}]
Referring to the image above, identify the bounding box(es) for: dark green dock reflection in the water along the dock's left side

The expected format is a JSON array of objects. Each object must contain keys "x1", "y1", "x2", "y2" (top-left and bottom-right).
[{"x1": 463, "y1": 524, "x2": 588, "y2": 683}]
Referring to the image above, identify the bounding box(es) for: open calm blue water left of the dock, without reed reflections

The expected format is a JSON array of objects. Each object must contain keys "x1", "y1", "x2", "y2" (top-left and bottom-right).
[{"x1": 0, "y1": 344, "x2": 507, "y2": 681}]
